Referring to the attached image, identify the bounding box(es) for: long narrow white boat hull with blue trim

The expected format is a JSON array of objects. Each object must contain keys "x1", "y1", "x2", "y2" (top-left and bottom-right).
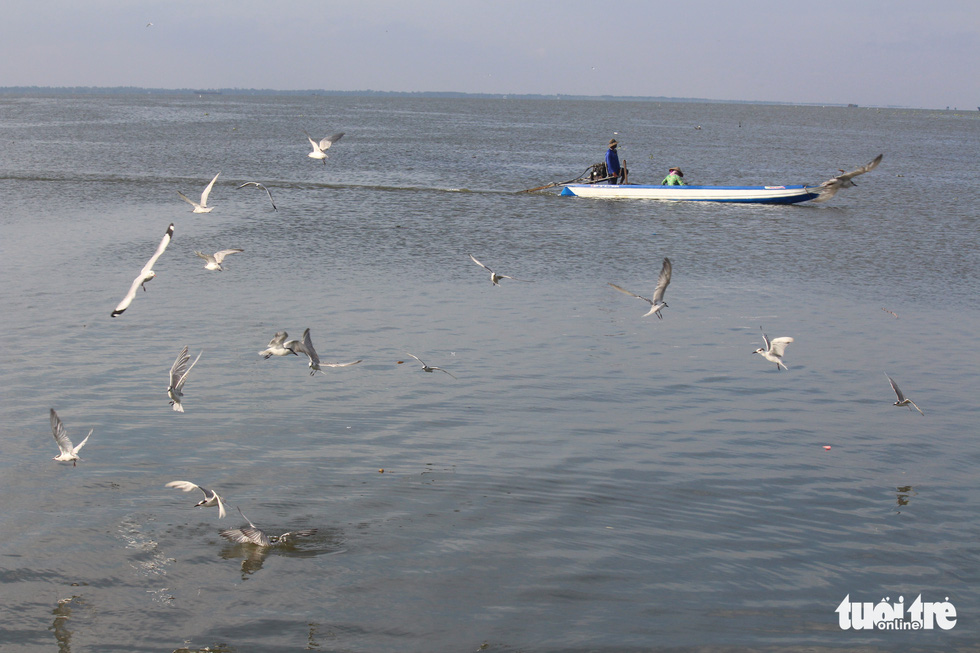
[{"x1": 561, "y1": 184, "x2": 819, "y2": 204}]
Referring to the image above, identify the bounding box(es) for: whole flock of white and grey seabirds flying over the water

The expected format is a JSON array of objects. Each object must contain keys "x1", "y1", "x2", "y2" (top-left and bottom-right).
[{"x1": 50, "y1": 140, "x2": 923, "y2": 548}]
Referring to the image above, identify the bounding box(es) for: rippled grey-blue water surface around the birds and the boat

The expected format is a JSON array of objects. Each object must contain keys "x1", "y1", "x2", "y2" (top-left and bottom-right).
[{"x1": 0, "y1": 95, "x2": 980, "y2": 653}]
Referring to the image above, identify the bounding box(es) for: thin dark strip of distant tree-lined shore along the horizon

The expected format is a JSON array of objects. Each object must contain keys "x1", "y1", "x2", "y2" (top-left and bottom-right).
[{"x1": 0, "y1": 86, "x2": 892, "y2": 109}]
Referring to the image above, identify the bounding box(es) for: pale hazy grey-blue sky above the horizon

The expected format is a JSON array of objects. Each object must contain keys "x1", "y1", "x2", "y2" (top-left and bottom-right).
[{"x1": 0, "y1": 0, "x2": 980, "y2": 109}]
